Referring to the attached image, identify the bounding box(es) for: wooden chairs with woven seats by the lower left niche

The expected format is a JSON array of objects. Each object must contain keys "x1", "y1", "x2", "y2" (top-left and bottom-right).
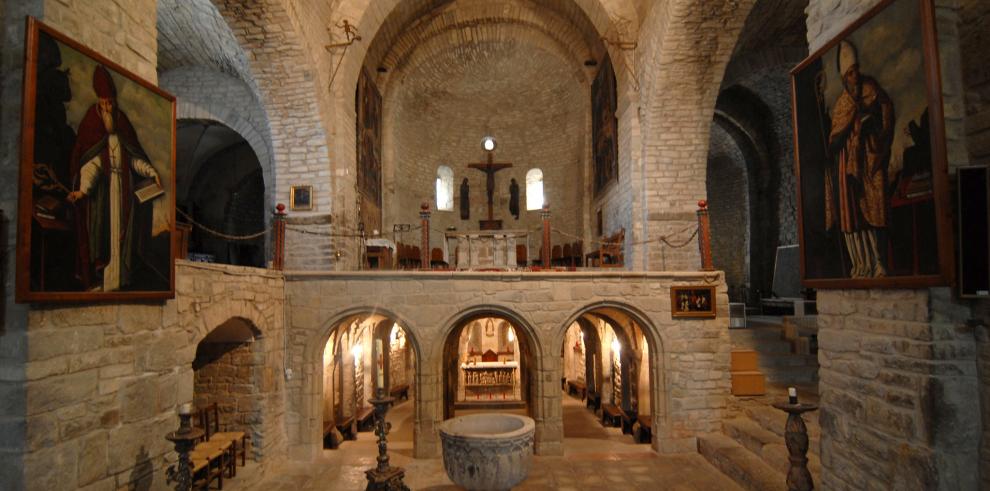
[{"x1": 189, "y1": 403, "x2": 251, "y2": 490}]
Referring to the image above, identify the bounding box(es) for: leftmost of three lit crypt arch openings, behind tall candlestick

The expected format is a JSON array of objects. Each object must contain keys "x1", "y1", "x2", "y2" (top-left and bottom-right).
[{"x1": 321, "y1": 314, "x2": 416, "y2": 449}]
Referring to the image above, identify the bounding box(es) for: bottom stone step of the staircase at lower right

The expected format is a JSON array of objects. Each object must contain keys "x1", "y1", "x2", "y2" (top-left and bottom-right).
[{"x1": 698, "y1": 433, "x2": 787, "y2": 491}]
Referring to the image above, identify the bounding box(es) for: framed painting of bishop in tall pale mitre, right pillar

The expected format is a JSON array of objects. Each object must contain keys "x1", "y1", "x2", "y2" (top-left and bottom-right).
[{"x1": 791, "y1": 0, "x2": 953, "y2": 288}]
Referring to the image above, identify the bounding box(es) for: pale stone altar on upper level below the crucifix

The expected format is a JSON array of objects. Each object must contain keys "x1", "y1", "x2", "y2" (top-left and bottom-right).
[{"x1": 443, "y1": 230, "x2": 530, "y2": 270}]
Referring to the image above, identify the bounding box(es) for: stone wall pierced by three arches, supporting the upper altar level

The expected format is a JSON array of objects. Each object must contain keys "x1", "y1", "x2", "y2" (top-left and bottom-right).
[{"x1": 286, "y1": 272, "x2": 729, "y2": 458}]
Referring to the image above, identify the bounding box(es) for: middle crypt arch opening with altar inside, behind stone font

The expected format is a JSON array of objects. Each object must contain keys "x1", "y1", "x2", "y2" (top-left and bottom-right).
[{"x1": 443, "y1": 314, "x2": 538, "y2": 419}]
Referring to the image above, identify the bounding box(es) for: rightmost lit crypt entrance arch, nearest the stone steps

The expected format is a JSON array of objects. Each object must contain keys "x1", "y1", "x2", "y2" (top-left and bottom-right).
[{"x1": 555, "y1": 302, "x2": 668, "y2": 449}]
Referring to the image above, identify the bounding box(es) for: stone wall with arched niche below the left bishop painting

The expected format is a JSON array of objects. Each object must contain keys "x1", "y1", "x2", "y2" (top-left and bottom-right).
[{"x1": 24, "y1": 261, "x2": 285, "y2": 490}]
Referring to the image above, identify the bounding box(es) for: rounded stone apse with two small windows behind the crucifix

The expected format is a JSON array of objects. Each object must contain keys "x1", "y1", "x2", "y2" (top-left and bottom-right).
[{"x1": 358, "y1": 0, "x2": 605, "y2": 257}]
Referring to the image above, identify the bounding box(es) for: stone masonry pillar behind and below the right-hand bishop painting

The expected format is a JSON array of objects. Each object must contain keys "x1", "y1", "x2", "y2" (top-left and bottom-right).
[{"x1": 807, "y1": 0, "x2": 990, "y2": 489}]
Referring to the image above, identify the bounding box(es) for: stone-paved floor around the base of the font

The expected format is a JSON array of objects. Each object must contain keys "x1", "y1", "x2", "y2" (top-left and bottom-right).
[{"x1": 234, "y1": 395, "x2": 741, "y2": 491}]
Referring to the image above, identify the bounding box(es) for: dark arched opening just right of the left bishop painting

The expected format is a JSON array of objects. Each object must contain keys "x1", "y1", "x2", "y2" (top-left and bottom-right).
[{"x1": 176, "y1": 119, "x2": 267, "y2": 267}]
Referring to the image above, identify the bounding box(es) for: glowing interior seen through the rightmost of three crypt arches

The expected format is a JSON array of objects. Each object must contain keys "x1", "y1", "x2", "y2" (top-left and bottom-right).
[{"x1": 561, "y1": 307, "x2": 659, "y2": 449}]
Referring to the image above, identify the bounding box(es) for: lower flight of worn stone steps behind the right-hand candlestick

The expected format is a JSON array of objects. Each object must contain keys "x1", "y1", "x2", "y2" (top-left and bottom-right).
[{"x1": 698, "y1": 386, "x2": 821, "y2": 491}]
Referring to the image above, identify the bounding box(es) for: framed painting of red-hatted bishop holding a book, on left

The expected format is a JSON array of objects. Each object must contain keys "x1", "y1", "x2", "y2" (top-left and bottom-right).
[{"x1": 16, "y1": 18, "x2": 175, "y2": 302}]
